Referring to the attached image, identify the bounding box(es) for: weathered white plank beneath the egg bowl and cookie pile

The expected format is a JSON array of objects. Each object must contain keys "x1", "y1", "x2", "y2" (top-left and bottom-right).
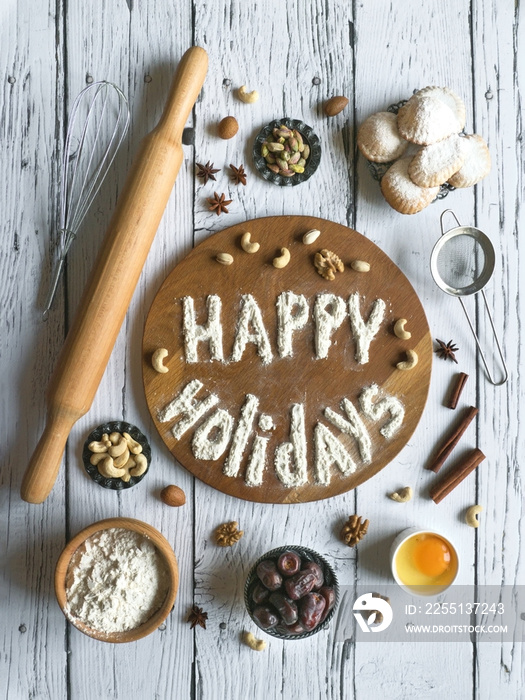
[{"x1": 345, "y1": 2, "x2": 476, "y2": 699}]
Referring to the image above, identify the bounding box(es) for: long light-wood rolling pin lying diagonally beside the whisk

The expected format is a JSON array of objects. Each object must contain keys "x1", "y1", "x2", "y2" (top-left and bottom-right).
[{"x1": 21, "y1": 46, "x2": 208, "y2": 503}]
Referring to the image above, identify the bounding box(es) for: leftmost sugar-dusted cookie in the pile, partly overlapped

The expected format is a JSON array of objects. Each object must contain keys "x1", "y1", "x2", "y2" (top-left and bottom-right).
[{"x1": 357, "y1": 112, "x2": 408, "y2": 163}]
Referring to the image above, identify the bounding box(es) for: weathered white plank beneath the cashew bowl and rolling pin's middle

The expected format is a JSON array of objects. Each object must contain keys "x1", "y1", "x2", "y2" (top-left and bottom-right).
[{"x1": 63, "y1": 3, "x2": 193, "y2": 698}]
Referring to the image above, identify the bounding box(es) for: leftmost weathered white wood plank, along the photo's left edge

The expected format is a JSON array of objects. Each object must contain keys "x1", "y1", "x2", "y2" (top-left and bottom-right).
[{"x1": 0, "y1": 3, "x2": 67, "y2": 698}]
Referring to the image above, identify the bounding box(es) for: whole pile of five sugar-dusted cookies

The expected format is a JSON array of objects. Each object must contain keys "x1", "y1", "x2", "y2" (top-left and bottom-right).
[{"x1": 357, "y1": 86, "x2": 491, "y2": 214}]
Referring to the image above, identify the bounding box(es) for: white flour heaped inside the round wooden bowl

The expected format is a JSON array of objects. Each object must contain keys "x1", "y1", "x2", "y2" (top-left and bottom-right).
[{"x1": 66, "y1": 528, "x2": 169, "y2": 634}]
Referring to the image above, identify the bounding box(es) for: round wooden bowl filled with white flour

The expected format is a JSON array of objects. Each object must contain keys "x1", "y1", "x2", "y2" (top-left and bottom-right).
[{"x1": 55, "y1": 518, "x2": 179, "y2": 643}]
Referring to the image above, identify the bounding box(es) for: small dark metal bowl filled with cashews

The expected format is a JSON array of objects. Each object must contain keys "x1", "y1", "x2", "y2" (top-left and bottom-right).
[{"x1": 82, "y1": 421, "x2": 151, "y2": 491}]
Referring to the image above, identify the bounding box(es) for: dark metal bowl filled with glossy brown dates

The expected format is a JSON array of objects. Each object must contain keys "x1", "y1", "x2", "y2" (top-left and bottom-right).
[{"x1": 244, "y1": 545, "x2": 339, "y2": 639}]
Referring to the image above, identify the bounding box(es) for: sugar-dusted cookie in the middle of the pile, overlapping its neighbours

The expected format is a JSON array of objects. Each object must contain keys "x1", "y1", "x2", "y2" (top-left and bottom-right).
[{"x1": 408, "y1": 134, "x2": 465, "y2": 187}]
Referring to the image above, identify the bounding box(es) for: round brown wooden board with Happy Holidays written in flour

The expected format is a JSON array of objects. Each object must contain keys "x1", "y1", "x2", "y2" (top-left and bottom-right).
[{"x1": 143, "y1": 216, "x2": 432, "y2": 503}]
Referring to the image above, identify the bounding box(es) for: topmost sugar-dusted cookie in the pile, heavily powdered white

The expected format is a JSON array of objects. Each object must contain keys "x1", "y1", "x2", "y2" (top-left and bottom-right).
[{"x1": 397, "y1": 94, "x2": 462, "y2": 146}]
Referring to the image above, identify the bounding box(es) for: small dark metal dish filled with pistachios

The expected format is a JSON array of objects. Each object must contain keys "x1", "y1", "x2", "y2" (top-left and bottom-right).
[{"x1": 253, "y1": 118, "x2": 321, "y2": 187}]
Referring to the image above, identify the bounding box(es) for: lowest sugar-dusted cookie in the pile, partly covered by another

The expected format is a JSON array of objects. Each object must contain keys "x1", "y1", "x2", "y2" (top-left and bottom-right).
[{"x1": 381, "y1": 157, "x2": 439, "y2": 214}]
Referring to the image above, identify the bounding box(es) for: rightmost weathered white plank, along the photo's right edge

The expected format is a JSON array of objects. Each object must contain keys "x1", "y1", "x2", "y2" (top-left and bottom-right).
[{"x1": 473, "y1": 2, "x2": 525, "y2": 699}]
